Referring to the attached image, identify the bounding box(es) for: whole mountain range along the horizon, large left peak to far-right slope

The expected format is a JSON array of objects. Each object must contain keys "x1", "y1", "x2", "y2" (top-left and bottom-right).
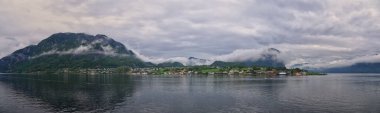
[{"x1": 0, "y1": 33, "x2": 380, "y2": 72}]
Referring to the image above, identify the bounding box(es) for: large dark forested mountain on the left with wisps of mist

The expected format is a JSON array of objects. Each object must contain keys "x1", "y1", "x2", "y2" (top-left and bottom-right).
[{"x1": 0, "y1": 33, "x2": 146, "y2": 72}]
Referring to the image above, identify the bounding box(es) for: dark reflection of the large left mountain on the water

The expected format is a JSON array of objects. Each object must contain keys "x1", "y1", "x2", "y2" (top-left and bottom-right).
[{"x1": 0, "y1": 75, "x2": 135, "y2": 112}]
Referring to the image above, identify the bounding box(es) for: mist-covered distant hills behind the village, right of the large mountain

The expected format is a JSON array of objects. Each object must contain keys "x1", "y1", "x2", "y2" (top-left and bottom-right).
[{"x1": 136, "y1": 48, "x2": 285, "y2": 67}]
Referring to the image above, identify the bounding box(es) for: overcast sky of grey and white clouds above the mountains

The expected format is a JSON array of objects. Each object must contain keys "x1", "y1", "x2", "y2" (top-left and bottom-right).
[{"x1": 0, "y1": 0, "x2": 380, "y2": 67}]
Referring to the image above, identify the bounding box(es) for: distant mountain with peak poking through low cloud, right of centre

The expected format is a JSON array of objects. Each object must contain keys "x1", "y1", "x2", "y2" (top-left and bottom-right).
[{"x1": 211, "y1": 48, "x2": 285, "y2": 67}]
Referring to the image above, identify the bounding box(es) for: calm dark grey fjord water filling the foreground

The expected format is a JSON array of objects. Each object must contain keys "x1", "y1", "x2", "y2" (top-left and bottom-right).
[{"x1": 0, "y1": 74, "x2": 380, "y2": 113}]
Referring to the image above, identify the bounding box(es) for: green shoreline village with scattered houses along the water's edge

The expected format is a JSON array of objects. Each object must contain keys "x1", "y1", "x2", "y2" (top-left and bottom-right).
[{"x1": 62, "y1": 66, "x2": 324, "y2": 76}]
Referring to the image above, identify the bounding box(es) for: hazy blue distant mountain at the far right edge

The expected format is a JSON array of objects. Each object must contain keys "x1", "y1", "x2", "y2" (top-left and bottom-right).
[{"x1": 321, "y1": 63, "x2": 380, "y2": 73}]
